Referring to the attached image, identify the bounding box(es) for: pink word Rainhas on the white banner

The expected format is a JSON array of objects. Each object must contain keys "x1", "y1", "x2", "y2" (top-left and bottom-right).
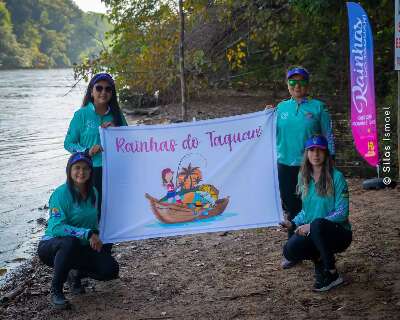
[{"x1": 115, "y1": 137, "x2": 178, "y2": 153}]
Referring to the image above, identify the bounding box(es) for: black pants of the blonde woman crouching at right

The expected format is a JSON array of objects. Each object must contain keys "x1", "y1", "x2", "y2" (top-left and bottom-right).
[{"x1": 283, "y1": 218, "x2": 352, "y2": 270}]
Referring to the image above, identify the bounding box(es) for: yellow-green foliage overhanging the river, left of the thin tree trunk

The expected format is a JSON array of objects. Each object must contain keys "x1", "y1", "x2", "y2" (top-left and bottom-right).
[{"x1": 83, "y1": 0, "x2": 178, "y2": 92}]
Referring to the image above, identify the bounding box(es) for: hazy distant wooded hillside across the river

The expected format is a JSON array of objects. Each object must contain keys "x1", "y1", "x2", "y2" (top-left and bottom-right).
[{"x1": 0, "y1": 0, "x2": 111, "y2": 68}]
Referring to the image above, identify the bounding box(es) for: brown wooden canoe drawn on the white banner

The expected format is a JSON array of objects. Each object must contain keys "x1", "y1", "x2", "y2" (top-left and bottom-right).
[{"x1": 145, "y1": 193, "x2": 229, "y2": 224}]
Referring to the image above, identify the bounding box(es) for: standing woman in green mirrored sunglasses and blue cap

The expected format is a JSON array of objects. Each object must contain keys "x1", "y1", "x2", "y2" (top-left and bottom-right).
[{"x1": 276, "y1": 67, "x2": 335, "y2": 269}]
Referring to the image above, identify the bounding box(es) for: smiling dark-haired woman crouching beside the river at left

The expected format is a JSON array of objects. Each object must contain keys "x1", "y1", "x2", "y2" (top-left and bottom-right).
[{"x1": 38, "y1": 152, "x2": 119, "y2": 309}]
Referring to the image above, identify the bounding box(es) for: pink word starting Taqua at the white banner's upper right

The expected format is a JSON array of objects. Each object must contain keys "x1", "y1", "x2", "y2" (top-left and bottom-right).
[{"x1": 205, "y1": 127, "x2": 262, "y2": 152}]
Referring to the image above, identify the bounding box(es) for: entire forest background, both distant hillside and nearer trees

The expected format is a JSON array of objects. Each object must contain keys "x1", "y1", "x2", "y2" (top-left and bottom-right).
[{"x1": 0, "y1": 0, "x2": 397, "y2": 177}]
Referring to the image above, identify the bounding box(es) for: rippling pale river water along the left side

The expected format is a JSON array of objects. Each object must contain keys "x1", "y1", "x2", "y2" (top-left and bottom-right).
[{"x1": 0, "y1": 69, "x2": 86, "y2": 282}]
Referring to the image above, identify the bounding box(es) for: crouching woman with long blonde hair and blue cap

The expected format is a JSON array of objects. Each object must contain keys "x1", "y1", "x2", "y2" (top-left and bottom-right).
[{"x1": 281, "y1": 136, "x2": 352, "y2": 291}]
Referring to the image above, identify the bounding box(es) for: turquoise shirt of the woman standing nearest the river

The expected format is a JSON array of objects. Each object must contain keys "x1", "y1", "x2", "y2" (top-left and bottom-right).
[{"x1": 64, "y1": 102, "x2": 128, "y2": 167}]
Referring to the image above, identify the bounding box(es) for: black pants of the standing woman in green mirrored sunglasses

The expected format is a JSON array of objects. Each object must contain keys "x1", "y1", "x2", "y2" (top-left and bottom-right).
[{"x1": 278, "y1": 163, "x2": 302, "y2": 238}]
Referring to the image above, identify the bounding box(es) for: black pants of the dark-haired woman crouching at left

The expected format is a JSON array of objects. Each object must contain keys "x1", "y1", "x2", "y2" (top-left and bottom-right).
[{"x1": 38, "y1": 236, "x2": 119, "y2": 292}]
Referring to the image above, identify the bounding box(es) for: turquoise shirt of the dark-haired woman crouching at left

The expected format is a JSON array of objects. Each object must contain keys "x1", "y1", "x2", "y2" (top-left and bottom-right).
[{"x1": 43, "y1": 183, "x2": 99, "y2": 244}]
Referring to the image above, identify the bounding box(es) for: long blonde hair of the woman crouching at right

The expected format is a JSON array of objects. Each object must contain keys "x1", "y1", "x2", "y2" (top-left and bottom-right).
[{"x1": 296, "y1": 149, "x2": 333, "y2": 199}]
